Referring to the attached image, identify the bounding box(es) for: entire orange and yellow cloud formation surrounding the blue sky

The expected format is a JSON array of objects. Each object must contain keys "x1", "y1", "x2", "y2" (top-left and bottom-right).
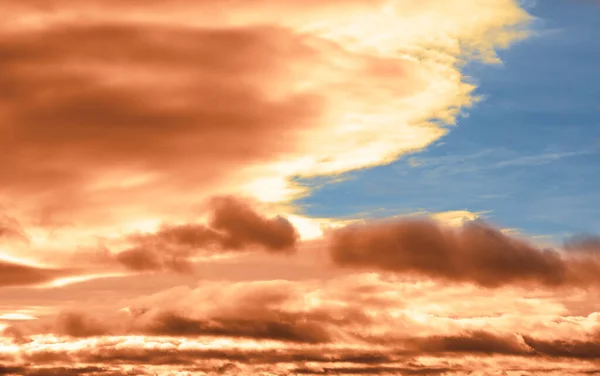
[{"x1": 0, "y1": 0, "x2": 600, "y2": 376}]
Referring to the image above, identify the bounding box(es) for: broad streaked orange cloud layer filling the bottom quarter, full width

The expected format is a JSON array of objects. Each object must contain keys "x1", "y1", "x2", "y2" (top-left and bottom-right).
[{"x1": 2, "y1": 274, "x2": 600, "y2": 375}]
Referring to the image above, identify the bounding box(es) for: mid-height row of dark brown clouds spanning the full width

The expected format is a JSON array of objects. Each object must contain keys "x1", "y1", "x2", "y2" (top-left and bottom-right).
[{"x1": 4, "y1": 209, "x2": 600, "y2": 289}]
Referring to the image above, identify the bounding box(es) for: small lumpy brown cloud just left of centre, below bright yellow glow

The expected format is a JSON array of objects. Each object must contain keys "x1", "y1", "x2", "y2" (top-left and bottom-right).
[{"x1": 115, "y1": 196, "x2": 299, "y2": 272}]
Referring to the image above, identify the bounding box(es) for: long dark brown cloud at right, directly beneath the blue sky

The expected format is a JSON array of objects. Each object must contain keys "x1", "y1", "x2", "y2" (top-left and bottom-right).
[{"x1": 329, "y1": 220, "x2": 600, "y2": 287}]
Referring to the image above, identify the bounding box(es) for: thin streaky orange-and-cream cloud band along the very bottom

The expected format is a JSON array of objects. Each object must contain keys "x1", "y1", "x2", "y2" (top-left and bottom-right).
[{"x1": 7, "y1": 331, "x2": 598, "y2": 375}]
